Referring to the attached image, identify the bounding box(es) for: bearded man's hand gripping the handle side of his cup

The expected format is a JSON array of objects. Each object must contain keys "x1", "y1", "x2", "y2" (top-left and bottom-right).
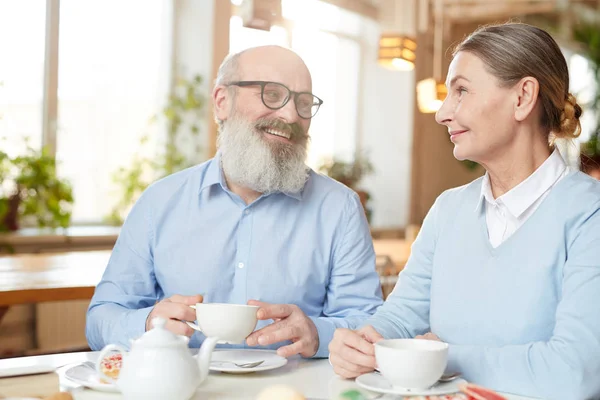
[{"x1": 146, "y1": 294, "x2": 204, "y2": 336}]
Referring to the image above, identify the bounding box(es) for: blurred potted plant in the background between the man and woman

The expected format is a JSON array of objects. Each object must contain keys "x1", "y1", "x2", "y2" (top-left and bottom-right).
[{"x1": 318, "y1": 155, "x2": 374, "y2": 222}]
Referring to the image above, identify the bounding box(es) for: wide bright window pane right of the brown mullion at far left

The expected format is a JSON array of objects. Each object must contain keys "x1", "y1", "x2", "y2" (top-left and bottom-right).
[{"x1": 56, "y1": 0, "x2": 170, "y2": 223}]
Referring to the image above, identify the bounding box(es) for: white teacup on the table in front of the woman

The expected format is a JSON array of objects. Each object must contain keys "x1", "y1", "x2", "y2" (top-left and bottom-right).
[{"x1": 375, "y1": 339, "x2": 448, "y2": 390}]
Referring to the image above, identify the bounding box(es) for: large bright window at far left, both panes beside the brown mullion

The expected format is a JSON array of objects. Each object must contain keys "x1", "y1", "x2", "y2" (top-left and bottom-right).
[{"x1": 0, "y1": 0, "x2": 172, "y2": 224}]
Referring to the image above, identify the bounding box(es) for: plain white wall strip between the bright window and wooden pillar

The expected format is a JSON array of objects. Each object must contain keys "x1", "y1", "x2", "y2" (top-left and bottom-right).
[{"x1": 359, "y1": 23, "x2": 415, "y2": 228}]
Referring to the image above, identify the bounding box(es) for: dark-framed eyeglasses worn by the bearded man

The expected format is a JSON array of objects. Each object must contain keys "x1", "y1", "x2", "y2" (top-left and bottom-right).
[{"x1": 226, "y1": 81, "x2": 323, "y2": 119}]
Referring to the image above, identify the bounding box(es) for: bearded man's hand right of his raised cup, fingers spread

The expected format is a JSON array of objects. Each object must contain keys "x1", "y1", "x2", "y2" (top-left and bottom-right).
[{"x1": 246, "y1": 300, "x2": 319, "y2": 357}]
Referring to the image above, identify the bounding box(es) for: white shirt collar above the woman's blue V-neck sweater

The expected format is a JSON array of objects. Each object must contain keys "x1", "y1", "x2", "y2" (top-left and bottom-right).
[{"x1": 477, "y1": 149, "x2": 567, "y2": 218}]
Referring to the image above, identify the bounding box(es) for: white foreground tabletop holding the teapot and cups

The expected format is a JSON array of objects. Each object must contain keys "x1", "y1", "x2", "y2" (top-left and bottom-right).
[{"x1": 0, "y1": 350, "x2": 532, "y2": 400}]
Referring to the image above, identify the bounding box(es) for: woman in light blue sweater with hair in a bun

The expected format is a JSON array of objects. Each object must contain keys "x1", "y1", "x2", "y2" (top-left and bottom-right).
[{"x1": 330, "y1": 24, "x2": 600, "y2": 399}]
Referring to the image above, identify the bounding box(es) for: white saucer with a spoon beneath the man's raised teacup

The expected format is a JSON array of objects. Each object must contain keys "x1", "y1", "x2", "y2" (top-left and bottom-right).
[{"x1": 210, "y1": 349, "x2": 287, "y2": 374}]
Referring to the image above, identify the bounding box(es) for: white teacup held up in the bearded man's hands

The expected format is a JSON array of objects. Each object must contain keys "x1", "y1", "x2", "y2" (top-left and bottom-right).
[{"x1": 186, "y1": 303, "x2": 259, "y2": 344}]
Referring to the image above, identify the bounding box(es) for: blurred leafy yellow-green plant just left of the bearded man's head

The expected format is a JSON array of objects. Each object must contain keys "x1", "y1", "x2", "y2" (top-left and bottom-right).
[{"x1": 106, "y1": 75, "x2": 206, "y2": 225}]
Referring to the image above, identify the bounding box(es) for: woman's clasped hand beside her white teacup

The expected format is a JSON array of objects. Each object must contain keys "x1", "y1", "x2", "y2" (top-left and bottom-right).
[{"x1": 329, "y1": 325, "x2": 383, "y2": 378}]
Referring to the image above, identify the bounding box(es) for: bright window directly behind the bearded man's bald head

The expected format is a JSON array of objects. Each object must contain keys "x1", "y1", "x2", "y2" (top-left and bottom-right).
[{"x1": 230, "y1": 0, "x2": 363, "y2": 168}]
